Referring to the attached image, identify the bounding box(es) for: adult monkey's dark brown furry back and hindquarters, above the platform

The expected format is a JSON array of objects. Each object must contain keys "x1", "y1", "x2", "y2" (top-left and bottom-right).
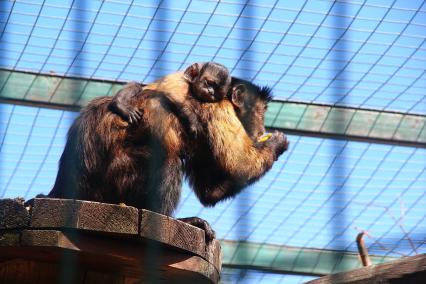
[{"x1": 49, "y1": 90, "x2": 183, "y2": 213}]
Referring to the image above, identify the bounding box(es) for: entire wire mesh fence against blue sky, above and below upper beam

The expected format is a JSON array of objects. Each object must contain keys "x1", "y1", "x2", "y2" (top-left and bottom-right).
[{"x1": 0, "y1": 0, "x2": 426, "y2": 283}]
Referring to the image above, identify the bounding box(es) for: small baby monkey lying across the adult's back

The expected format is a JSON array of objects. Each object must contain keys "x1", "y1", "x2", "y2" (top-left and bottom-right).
[{"x1": 109, "y1": 62, "x2": 231, "y2": 134}]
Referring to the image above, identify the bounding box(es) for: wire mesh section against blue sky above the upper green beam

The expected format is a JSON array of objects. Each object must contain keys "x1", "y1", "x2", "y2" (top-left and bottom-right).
[{"x1": 0, "y1": 1, "x2": 426, "y2": 113}]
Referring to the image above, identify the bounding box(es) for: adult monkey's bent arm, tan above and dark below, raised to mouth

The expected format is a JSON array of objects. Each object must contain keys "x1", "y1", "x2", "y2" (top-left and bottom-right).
[{"x1": 186, "y1": 101, "x2": 288, "y2": 206}]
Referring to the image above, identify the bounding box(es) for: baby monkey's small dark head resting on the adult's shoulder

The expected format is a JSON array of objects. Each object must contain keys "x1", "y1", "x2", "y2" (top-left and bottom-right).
[{"x1": 184, "y1": 62, "x2": 231, "y2": 102}]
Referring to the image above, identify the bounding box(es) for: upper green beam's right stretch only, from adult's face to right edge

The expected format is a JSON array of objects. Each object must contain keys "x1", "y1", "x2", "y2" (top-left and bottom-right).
[{"x1": 265, "y1": 101, "x2": 426, "y2": 148}]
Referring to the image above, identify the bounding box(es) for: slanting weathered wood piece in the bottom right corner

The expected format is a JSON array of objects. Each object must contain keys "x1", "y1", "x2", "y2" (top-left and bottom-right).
[{"x1": 307, "y1": 254, "x2": 426, "y2": 284}]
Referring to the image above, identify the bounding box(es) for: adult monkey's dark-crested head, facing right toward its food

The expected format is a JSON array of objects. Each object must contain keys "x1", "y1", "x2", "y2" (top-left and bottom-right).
[{"x1": 228, "y1": 77, "x2": 272, "y2": 141}]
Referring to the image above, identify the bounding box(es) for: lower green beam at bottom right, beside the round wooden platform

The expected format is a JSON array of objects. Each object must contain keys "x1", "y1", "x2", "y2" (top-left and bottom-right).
[{"x1": 221, "y1": 240, "x2": 397, "y2": 275}]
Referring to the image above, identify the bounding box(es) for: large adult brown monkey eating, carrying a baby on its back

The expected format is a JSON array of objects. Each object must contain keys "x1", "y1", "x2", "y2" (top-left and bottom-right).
[{"x1": 48, "y1": 65, "x2": 288, "y2": 240}]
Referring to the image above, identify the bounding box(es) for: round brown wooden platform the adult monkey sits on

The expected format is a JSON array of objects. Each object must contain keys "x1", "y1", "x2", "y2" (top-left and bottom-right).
[{"x1": 0, "y1": 199, "x2": 221, "y2": 284}]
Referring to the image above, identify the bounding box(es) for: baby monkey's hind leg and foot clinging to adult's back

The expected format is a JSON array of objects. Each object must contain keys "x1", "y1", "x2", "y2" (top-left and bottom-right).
[{"x1": 109, "y1": 82, "x2": 142, "y2": 124}]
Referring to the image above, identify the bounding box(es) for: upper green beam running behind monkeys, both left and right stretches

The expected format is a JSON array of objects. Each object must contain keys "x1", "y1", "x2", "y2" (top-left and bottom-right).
[{"x1": 0, "y1": 70, "x2": 426, "y2": 147}]
